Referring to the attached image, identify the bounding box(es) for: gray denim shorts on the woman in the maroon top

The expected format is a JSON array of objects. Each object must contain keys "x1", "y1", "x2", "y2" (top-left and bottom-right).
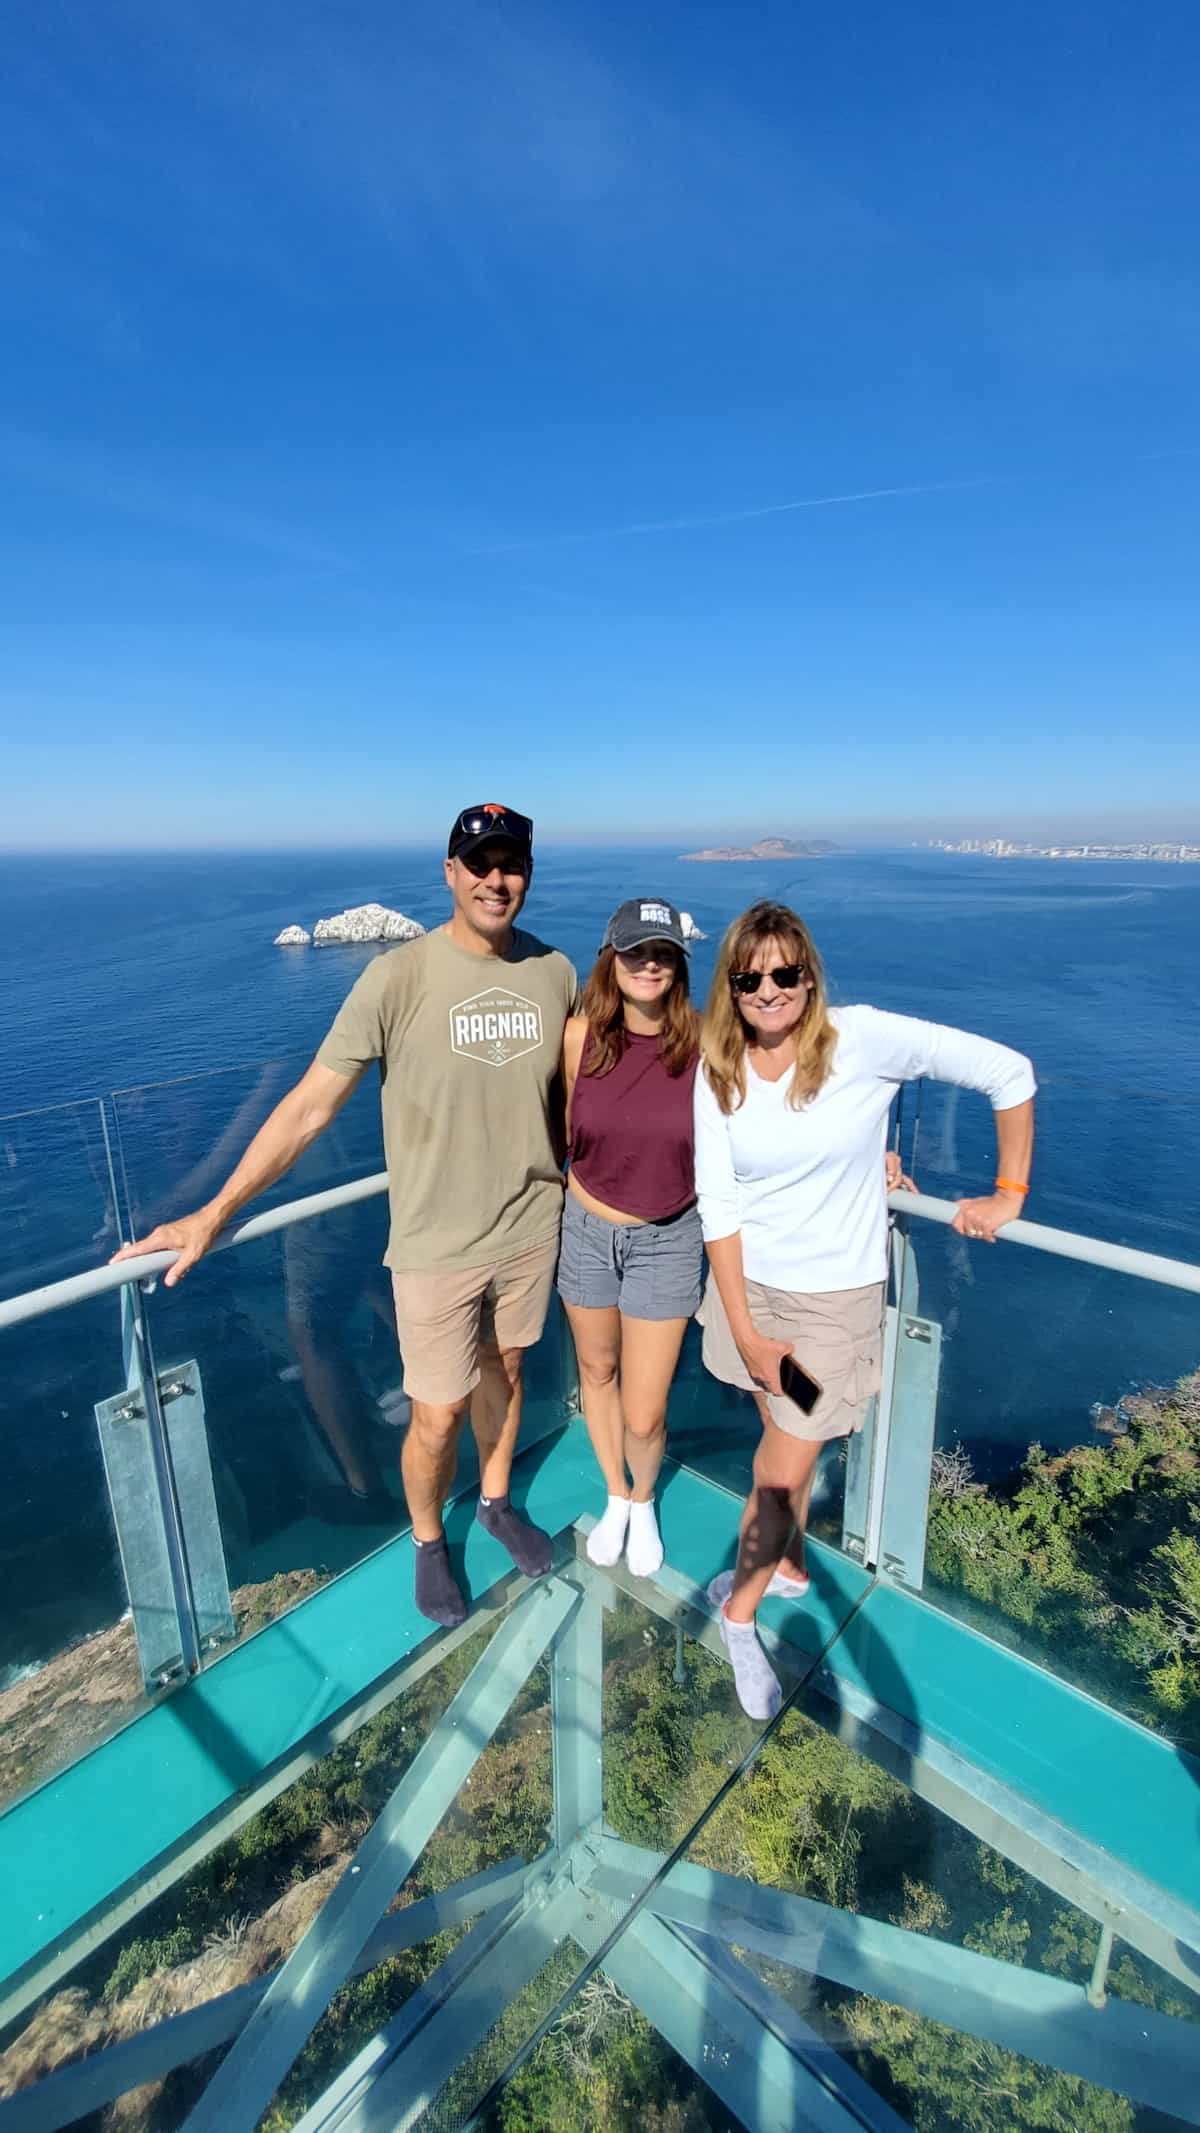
[{"x1": 558, "y1": 1192, "x2": 703, "y2": 1318}]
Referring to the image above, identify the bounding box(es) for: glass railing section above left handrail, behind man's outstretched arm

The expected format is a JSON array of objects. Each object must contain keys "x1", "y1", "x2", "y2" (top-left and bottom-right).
[{"x1": 111, "y1": 1052, "x2": 384, "y2": 1237}]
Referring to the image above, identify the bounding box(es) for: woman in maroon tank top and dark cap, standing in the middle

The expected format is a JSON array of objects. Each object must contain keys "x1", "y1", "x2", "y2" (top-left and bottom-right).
[{"x1": 558, "y1": 898, "x2": 703, "y2": 1576}]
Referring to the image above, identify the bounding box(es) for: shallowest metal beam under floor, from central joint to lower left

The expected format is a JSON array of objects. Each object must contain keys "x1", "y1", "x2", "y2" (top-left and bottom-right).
[{"x1": 0, "y1": 1860, "x2": 530, "y2": 2133}]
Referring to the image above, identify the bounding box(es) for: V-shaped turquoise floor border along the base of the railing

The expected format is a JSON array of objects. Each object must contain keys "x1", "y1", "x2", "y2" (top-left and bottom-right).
[{"x1": 0, "y1": 1423, "x2": 1200, "y2": 1979}]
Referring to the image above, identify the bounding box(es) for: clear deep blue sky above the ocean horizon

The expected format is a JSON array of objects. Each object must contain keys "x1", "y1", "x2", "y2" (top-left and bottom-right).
[{"x1": 0, "y1": 0, "x2": 1200, "y2": 845}]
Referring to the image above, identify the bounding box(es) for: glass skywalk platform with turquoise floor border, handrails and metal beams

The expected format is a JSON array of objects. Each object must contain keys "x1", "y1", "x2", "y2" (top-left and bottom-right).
[{"x1": 0, "y1": 1075, "x2": 1200, "y2": 2133}]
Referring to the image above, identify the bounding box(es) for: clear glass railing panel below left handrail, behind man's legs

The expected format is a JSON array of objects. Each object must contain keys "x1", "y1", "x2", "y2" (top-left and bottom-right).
[{"x1": 133, "y1": 1194, "x2": 569, "y2": 1653}]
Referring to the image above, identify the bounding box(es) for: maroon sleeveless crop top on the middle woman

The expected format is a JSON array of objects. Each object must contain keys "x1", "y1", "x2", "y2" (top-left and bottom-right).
[{"x1": 571, "y1": 1030, "x2": 697, "y2": 1222}]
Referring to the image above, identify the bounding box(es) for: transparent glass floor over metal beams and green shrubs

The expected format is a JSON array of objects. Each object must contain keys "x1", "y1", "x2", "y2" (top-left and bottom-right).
[{"x1": 0, "y1": 1559, "x2": 1200, "y2": 2133}]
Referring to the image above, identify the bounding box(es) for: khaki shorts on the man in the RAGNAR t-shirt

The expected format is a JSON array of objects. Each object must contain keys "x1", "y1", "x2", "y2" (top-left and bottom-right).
[{"x1": 392, "y1": 1231, "x2": 558, "y2": 1408}]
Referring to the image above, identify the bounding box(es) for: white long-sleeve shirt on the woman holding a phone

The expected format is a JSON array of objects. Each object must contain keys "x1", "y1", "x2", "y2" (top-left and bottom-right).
[{"x1": 695, "y1": 1007, "x2": 1038, "y2": 1295}]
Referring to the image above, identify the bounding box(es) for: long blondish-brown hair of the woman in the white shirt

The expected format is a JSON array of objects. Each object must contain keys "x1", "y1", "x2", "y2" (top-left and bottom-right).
[{"x1": 699, "y1": 902, "x2": 838, "y2": 1113}]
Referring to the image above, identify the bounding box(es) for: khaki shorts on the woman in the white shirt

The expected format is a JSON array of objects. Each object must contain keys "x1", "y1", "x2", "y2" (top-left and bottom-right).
[{"x1": 697, "y1": 1278, "x2": 882, "y2": 1444}]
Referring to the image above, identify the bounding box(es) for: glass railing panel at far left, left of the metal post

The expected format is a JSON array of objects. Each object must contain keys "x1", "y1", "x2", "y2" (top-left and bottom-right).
[{"x1": 0, "y1": 1105, "x2": 166, "y2": 1805}]
